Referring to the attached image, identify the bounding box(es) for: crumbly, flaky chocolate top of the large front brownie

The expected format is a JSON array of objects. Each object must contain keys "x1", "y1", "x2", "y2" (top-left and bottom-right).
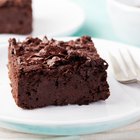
[{"x1": 9, "y1": 36, "x2": 100, "y2": 68}]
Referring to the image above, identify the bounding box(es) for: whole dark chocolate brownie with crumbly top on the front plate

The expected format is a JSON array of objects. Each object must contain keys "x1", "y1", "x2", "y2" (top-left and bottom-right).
[{"x1": 8, "y1": 36, "x2": 110, "y2": 109}]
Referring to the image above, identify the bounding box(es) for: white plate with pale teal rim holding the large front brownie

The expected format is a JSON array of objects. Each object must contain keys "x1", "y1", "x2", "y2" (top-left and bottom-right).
[{"x1": 0, "y1": 38, "x2": 140, "y2": 135}]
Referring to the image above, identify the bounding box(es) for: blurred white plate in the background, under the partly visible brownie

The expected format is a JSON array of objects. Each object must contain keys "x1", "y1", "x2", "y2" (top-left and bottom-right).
[{"x1": 33, "y1": 0, "x2": 85, "y2": 36}]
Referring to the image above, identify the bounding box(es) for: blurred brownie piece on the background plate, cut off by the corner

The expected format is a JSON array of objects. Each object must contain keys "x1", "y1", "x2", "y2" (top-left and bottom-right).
[{"x1": 0, "y1": 0, "x2": 32, "y2": 34}]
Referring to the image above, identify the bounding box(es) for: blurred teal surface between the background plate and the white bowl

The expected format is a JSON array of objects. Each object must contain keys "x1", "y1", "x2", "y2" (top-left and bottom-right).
[{"x1": 73, "y1": 0, "x2": 120, "y2": 41}]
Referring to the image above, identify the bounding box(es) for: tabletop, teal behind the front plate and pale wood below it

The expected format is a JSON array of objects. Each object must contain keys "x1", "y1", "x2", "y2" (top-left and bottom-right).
[{"x1": 0, "y1": 0, "x2": 140, "y2": 140}]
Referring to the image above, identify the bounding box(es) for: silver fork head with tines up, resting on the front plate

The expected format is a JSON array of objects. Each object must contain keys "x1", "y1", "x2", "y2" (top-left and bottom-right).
[{"x1": 109, "y1": 50, "x2": 140, "y2": 84}]
